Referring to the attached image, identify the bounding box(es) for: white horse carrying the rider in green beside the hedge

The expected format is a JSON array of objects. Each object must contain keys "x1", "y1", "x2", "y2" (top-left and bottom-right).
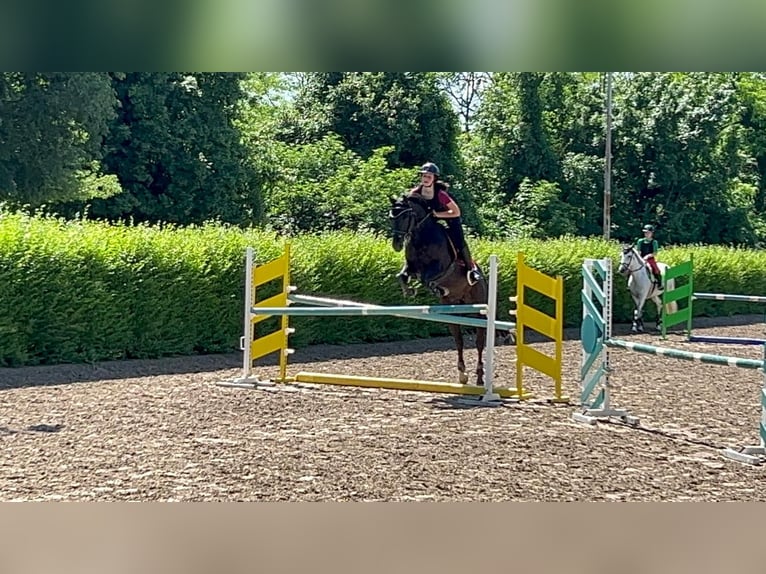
[{"x1": 617, "y1": 245, "x2": 678, "y2": 333}]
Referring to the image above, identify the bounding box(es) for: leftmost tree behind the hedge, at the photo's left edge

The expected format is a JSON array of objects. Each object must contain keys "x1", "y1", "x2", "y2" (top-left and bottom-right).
[{"x1": 0, "y1": 72, "x2": 119, "y2": 208}]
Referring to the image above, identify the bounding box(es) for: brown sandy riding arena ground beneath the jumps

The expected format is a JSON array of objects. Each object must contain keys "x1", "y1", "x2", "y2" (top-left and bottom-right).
[{"x1": 0, "y1": 317, "x2": 766, "y2": 501}]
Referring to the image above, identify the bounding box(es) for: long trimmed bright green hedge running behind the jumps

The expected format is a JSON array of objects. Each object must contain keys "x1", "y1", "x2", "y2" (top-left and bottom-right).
[{"x1": 0, "y1": 214, "x2": 766, "y2": 366}]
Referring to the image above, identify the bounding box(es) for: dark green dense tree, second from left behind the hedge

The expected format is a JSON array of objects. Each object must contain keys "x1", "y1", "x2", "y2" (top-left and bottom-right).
[{"x1": 89, "y1": 73, "x2": 263, "y2": 228}]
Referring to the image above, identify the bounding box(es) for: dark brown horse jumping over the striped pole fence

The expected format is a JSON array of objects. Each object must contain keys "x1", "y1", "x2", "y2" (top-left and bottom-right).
[{"x1": 389, "y1": 196, "x2": 488, "y2": 385}]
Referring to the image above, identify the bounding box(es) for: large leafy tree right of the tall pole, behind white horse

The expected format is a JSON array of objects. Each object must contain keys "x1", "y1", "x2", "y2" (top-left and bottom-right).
[{"x1": 613, "y1": 73, "x2": 754, "y2": 244}]
